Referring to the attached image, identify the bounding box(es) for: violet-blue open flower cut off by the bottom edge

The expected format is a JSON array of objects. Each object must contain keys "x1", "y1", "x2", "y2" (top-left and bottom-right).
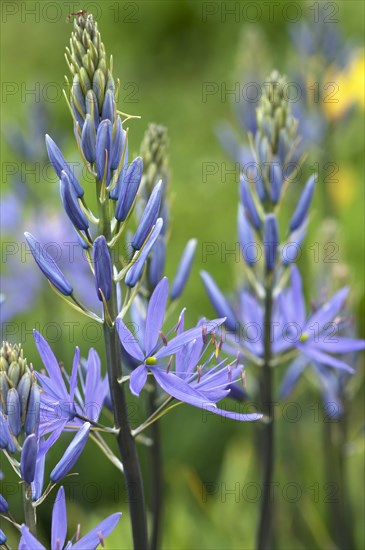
[{"x1": 19, "y1": 487, "x2": 122, "y2": 550}]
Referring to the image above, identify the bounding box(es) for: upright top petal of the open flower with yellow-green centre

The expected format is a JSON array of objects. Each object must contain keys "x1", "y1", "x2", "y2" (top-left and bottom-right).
[{"x1": 144, "y1": 277, "x2": 169, "y2": 357}]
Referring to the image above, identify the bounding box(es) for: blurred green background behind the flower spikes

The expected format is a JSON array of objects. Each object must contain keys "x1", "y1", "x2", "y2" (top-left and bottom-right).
[{"x1": 1, "y1": 0, "x2": 364, "y2": 549}]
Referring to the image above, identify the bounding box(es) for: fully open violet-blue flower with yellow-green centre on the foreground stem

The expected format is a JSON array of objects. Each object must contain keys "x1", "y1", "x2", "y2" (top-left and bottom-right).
[{"x1": 116, "y1": 277, "x2": 260, "y2": 420}]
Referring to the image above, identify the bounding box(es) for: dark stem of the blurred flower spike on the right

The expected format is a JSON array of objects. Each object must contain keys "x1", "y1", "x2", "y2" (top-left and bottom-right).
[{"x1": 256, "y1": 275, "x2": 274, "y2": 550}]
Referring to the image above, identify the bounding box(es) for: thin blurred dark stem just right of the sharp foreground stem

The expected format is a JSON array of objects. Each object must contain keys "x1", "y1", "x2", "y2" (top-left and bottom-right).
[{"x1": 148, "y1": 380, "x2": 163, "y2": 550}]
